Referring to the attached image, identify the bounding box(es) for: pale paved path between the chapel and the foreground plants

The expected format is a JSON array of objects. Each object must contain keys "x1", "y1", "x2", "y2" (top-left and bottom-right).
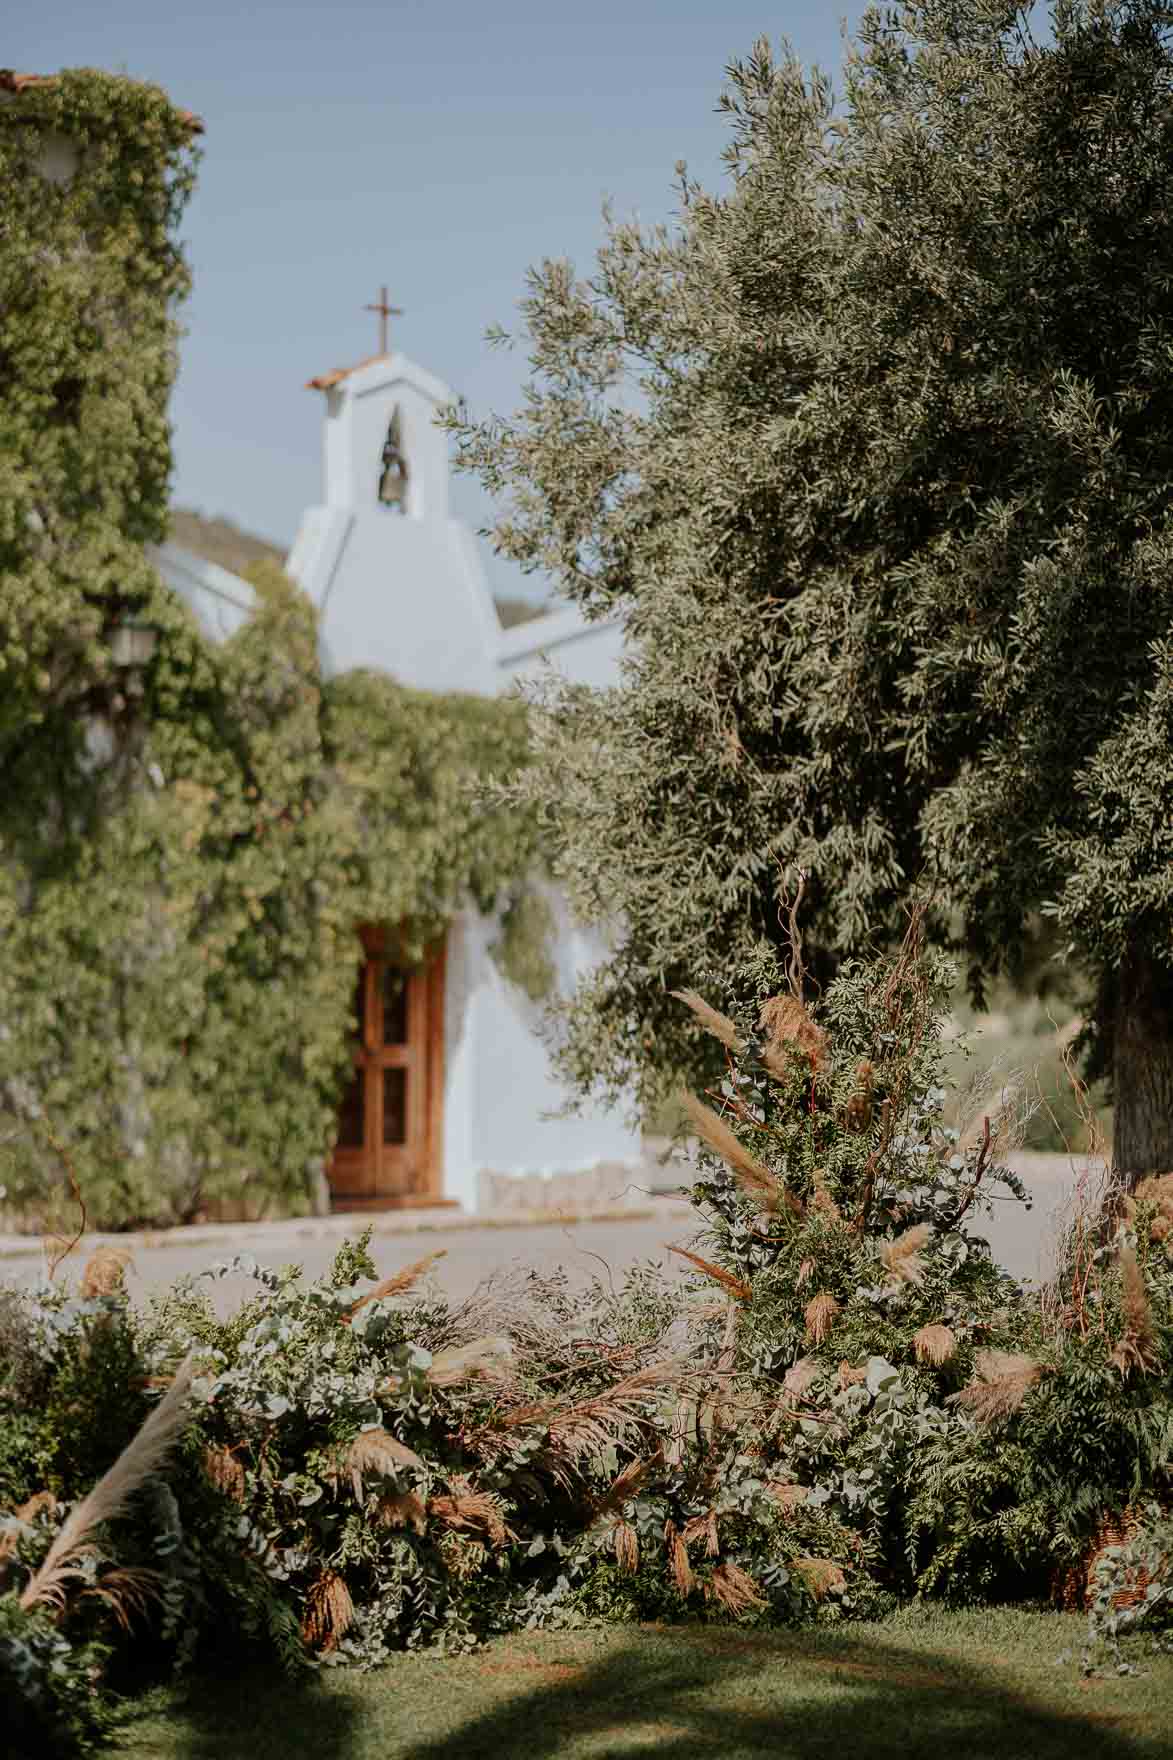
[{"x1": 0, "y1": 1155, "x2": 1081, "y2": 1313}]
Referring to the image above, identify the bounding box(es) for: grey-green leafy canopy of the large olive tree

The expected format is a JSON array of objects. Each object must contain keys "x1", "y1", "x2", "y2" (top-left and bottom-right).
[{"x1": 443, "y1": 0, "x2": 1173, "y2": 1147}]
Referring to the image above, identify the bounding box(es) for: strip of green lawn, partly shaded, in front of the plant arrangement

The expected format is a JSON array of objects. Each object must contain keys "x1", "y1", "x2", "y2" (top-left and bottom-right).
[{"x1": 116, "y1": 1609, "x2": 1173, "y2": 1760}]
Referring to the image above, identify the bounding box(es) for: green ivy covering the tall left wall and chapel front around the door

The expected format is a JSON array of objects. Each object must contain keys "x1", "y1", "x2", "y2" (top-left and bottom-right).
[{"x1": 0, "y1": 72, "x2": 539, "y2": 1227}]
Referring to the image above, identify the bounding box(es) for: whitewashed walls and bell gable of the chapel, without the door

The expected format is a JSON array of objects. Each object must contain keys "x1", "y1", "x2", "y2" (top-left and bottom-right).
[{"x1": 155, "y1": 344, "x2": 641, "y2": 1209}]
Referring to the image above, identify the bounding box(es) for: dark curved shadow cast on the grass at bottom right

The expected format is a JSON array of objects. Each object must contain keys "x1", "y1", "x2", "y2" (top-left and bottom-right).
[{"x1": 387, "y1": 1630, "x2": 1173, "y2": 1760}]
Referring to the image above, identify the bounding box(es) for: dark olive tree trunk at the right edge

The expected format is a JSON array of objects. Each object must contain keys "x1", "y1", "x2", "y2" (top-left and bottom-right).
[{"x1": 1113, "y1": 949, "x2": 1173, "y2": 1190}]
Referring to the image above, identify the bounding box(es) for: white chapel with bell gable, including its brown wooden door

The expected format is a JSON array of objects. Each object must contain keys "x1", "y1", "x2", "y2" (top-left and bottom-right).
[{"x1": 155, "y1": 337, "x2": 643, "y2": 1211}]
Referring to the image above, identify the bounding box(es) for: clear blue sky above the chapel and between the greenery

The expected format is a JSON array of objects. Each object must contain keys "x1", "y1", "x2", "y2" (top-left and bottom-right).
[{"x1": 15, "y1": 0, "x2": 877, "y2": 597}]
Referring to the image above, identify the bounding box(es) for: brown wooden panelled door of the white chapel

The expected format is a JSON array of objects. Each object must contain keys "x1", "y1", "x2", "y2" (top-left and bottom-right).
[{"x1": 329, "y1": 929, "x2": 444, "y2": 1209}]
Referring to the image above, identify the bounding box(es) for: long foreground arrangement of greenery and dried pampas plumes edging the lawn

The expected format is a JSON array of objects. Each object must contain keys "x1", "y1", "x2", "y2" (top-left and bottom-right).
[{"x1": 0, "y1": 935, "x2": 1173, "y2": 1742}]
